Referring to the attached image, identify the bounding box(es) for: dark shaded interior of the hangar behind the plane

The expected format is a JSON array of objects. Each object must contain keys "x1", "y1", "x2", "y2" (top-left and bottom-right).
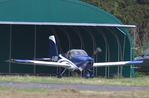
[{"x1": 0, "y1": 25, "x2": 130, "y2": 77}]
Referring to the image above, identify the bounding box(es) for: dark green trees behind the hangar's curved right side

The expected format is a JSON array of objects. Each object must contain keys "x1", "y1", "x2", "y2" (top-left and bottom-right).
[{"x1": 82, "y1": 0, "x2": 149, "y2": 55}]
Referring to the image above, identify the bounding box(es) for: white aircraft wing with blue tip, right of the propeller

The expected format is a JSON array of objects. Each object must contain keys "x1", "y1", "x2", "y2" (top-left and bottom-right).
[{"x1": 93, "y1": 61, "x2": 143, "y2": 67}]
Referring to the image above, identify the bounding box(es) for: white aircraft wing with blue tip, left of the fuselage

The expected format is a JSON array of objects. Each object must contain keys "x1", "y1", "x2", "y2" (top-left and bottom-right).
[{"x1": 7, "y1": 59, "x2": 71, "y2": 68}]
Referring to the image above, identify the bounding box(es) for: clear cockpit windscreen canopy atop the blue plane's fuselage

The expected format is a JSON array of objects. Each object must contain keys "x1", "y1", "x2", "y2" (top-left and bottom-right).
[{"x1": 67, "y1": 49, "x2": 88, "y2": 58}]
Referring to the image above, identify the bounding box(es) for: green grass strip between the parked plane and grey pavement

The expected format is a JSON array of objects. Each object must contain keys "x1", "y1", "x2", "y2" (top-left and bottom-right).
[{"x1": 0, "y1": 76, "x2": 149, "y2": 86}]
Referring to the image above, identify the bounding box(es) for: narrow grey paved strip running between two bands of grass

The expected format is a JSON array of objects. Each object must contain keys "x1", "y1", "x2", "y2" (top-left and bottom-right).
[{"x1": 0, "y1": 82, "x2": 149, "y2": 91}]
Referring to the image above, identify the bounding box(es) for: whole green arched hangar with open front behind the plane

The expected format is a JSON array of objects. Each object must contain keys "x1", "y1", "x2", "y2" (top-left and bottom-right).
[{"x1": 0, "y1": 0, "x2": 133, "y2": 77}]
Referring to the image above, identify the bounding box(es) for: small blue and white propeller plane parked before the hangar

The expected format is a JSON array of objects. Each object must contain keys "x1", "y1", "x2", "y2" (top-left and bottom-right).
[{"x1": 8, "y1": 35, "x2": 142, "y2": 77}]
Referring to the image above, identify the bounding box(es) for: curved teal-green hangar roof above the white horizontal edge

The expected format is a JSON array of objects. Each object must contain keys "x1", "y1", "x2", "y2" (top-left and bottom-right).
[{"x1": 0, "y1": 0, "x2": 121, "y2": 23}]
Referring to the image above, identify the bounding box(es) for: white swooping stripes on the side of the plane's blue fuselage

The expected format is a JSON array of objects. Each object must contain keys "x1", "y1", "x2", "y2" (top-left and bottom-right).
[{"x1": 58, "y1": 54, "x2": 79, "y2": 71}]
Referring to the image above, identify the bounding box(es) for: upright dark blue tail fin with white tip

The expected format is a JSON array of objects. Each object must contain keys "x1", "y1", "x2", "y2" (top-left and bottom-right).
[{"x1": 49, "y1": 35, "x2": 58, "y2": 61}]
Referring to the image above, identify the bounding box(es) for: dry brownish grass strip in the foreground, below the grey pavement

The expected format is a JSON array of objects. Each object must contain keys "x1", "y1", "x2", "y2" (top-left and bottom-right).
[{"x1": 0, "y1": 88, "x2": 149, "y2": 98}]
